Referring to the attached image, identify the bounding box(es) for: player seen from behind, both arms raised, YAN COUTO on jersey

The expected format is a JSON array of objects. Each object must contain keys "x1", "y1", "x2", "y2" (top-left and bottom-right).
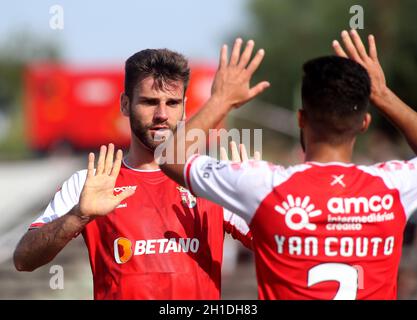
[{"x1": 161, "y1": 31, "x2": 417, "y2": 299}]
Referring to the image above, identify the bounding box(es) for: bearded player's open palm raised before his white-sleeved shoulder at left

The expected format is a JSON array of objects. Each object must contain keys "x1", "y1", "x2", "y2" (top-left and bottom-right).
[{"x1": 78, "y1": 144, "x2": 135, "y2": 218}]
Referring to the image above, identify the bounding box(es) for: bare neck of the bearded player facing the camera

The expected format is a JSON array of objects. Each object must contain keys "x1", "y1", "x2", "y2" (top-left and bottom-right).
[{"x1": 125, "y1": 134, "x2": 159, "y2": 170}]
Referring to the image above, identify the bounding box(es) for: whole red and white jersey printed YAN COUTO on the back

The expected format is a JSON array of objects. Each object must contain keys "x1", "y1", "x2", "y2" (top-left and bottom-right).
[{"x1": 184, "y1": 156, "x2": 417, "y2": 299}]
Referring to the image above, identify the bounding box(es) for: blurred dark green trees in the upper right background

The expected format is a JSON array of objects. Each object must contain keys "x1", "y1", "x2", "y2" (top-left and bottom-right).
[{"x1": 246, "y1": 0, "x2": 417, "y2": 136}]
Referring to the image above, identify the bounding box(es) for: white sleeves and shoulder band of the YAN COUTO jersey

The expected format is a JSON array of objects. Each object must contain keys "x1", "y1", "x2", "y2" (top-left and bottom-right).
[{"x1": 184, "y1": 156, "x2": 417, "y2": 224}]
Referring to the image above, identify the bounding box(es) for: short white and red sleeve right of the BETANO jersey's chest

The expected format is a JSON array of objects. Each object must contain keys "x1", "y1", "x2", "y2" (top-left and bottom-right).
[{"x1": 223, "y1": 208, "x2": 252, "y2": 250}]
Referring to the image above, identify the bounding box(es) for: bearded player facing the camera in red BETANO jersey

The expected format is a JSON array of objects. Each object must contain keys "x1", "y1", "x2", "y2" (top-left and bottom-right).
[{"x1": 14, "y1": 49, "x2": 251, "y2": 299}]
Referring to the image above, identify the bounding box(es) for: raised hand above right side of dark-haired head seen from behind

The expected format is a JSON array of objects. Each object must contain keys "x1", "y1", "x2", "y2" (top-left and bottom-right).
[{"x1": 333, "y1": 30, "x2": 387, "y2": 102}]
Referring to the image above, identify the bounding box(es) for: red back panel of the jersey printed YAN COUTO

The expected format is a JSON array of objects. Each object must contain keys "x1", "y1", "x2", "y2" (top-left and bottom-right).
[{"x1": 251, "y1": 163, "x2": 408, "y2": 299}]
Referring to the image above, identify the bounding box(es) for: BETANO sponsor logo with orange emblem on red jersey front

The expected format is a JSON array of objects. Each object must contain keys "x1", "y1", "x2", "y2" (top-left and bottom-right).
[{"x1": 114, "y1": 237, "x2": 200, "y2": 264}]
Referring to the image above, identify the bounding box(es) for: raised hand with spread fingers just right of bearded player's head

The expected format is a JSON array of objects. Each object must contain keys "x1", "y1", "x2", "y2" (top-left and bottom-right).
[{"x1": 212, "y1": 38, "x2": 269, "y2": 108}]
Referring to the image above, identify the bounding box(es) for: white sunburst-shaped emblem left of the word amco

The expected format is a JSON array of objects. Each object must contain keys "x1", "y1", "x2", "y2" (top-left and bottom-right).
[{"x1": 275, "y1": 195, "x2": 322, "y2": 231}]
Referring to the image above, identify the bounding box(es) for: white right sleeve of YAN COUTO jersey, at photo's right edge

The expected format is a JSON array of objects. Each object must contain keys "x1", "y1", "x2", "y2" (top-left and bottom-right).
[{"x1": 360, "y1": 158, "x2": 417, "y2": 220}]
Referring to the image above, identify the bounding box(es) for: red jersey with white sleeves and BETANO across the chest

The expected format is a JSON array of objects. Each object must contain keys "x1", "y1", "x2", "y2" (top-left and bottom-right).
[{"x1": 30, "y1": 165, "x2": 252, "y2": 300}]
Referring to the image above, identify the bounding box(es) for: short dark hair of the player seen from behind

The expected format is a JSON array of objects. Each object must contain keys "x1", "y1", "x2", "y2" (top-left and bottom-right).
[{"x1": 302, "y1": 56, "x2": 371, "y2": 143}]
